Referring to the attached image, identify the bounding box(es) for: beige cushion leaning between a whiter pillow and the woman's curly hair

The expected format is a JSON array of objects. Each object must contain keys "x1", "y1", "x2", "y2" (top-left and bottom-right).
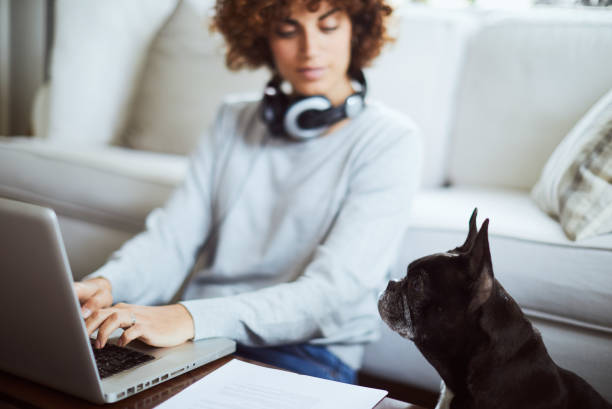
[{"x1": 123, "y1": 0, "x2": 269, "y2": 154}]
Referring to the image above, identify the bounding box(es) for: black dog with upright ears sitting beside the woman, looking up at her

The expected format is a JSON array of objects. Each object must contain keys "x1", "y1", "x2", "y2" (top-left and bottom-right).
[{"x1": 378, "y1": 210, "x2": 612, "y2": 409}]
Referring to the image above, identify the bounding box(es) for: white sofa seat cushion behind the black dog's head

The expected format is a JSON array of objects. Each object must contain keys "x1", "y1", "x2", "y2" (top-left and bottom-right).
[{"x1": 394, "y1": 187, "x2": 612, "y2": 333}]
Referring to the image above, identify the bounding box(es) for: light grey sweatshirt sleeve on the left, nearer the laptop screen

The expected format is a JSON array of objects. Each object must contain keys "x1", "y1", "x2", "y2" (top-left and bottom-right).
[{"x1": 85, "y1": 103, "x2": 230, "y2": 305}]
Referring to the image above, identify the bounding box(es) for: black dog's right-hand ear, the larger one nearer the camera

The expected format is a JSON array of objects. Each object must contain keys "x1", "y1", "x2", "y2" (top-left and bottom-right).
[{"x1": 468, "y1": 219, "x2": 495, "y2": 311}]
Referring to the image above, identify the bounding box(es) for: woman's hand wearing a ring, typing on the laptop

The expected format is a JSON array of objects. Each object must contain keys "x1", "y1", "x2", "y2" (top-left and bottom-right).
[{"x1": 85, "y1": 303, "x2": 194, "y2": 348}]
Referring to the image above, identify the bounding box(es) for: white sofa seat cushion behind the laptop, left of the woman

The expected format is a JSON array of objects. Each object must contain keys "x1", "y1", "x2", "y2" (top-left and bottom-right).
[{"x1": 0, "y1": 138, "x2": 187, "y2": 233}]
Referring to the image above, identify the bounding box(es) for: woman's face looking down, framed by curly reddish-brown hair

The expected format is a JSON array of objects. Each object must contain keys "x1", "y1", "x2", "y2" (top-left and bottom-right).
[{"x1": 269, "y1": 1, "x2": 353, "y2": 105}]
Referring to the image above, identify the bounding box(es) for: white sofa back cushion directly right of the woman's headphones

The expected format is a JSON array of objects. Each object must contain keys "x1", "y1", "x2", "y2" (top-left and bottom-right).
[{"x1": 365, "y1": 2, "x2": 477, "y2": 187}]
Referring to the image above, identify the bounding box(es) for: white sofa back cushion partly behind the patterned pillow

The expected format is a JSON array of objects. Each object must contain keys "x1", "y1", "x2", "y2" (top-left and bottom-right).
[{"x1": 449, "y1": 8, "x2": 612, "y2": 189}]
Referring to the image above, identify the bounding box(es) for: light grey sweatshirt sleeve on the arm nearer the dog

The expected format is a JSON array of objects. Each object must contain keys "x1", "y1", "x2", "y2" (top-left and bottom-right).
[{"x1": 182, "y1": 124, "x2": 422, "y2": 345}]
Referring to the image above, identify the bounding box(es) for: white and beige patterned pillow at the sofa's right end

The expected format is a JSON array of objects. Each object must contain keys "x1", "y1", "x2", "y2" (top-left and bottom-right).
[{"x1": 532, "y1": 86, "x2": 612, "y2": 240}]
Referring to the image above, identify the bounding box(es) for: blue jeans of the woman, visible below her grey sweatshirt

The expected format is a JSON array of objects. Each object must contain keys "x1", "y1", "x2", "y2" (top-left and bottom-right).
[{"x1": 236, "y1": 344, "x2": 357, "y2": 384}]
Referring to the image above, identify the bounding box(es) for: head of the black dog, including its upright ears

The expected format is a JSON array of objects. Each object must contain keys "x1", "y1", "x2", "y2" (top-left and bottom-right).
[{"x1": 378, "y1": 210, "x2": 493, "y2": 350}]
